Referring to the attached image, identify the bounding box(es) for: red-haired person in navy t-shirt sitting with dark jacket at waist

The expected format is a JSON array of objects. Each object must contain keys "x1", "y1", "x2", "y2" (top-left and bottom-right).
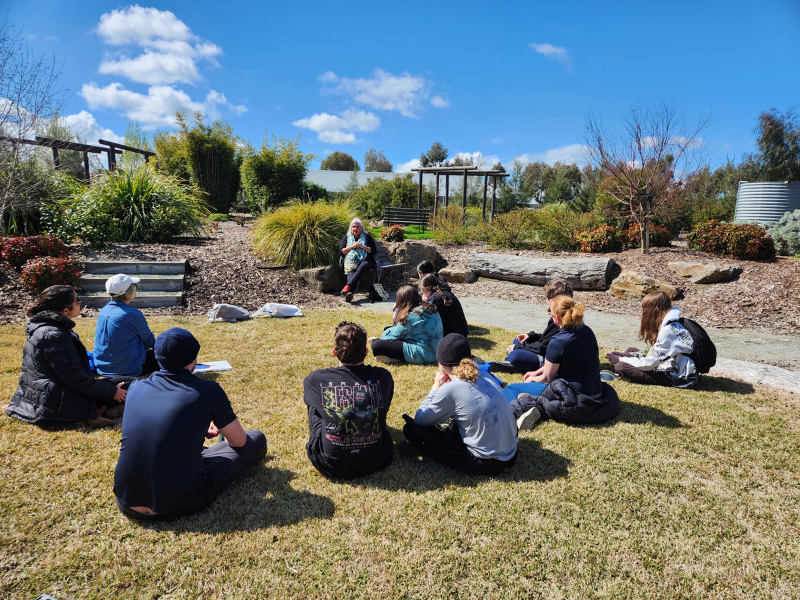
[{"x1": 508, "y1": 296, "x2": 619, "y2": 429}]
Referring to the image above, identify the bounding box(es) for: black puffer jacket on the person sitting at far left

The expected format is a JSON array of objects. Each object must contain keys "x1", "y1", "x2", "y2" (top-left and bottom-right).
[{"x1": 6, "y1": 311, "x2": 117, "y2": 423}]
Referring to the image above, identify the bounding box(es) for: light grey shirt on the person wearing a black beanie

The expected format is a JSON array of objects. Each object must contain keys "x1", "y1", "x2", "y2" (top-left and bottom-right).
[{"x1": 414, "y1": 373, "x2": 517, "y2": 460}]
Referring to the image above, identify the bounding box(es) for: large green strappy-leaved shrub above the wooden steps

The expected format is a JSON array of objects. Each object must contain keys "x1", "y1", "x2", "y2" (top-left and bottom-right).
[{"x1": 43, "y1": 166, "x2": 209, "y2": 246}]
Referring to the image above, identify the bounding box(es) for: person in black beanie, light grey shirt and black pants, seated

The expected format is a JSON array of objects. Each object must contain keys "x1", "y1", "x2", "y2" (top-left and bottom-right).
[{"x1": 403, "y1": 333, "x2": 517, "y2": 475}]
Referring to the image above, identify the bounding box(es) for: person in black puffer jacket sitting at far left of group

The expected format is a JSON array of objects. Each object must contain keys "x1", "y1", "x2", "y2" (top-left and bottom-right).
[{"x1": 6, "y1": 285, "x2": 126, "y2": 427}]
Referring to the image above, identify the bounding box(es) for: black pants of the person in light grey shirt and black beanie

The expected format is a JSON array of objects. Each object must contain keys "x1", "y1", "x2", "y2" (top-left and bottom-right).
[{"x1": 403, "y1": 415, "x2": 517, "y2": 475}]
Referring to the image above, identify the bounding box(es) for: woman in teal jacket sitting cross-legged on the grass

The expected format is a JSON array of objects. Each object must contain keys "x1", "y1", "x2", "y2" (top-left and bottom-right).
[{"x1": 372, "y1": 285, "x2": 442, "y2": 365}]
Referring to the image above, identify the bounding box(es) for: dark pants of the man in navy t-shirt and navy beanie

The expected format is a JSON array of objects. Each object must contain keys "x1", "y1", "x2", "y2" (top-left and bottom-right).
[{"x1": 117, "y1": 430, "x2": 267, "y2": 521}]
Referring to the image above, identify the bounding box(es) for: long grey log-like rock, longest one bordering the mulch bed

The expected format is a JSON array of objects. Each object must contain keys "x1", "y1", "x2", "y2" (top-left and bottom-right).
[{"x1": 467, "y1": 252, "x2": 614, "y2": 290}]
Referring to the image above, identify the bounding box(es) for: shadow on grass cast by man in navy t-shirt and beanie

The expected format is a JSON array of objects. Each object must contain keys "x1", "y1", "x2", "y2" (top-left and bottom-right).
[{"x1": 142, "y1": 463, "x2": 335, "y2": 533}]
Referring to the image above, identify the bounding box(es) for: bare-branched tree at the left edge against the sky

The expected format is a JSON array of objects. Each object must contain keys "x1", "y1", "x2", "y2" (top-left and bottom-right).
[{"x1": 0, "y1": 20, "x2": 64, "y2": 234}]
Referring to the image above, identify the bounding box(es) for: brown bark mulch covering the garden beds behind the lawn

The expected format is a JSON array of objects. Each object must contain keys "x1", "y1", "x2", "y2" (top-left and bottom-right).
[{"x1": 0, "y1": 222, "x2": 800, "y2": 333}]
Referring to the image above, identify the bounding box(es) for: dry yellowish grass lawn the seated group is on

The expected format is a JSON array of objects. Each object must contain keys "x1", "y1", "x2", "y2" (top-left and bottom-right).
[{"x1": 0, "y1": 309, "x2": 800, "y2": 600}]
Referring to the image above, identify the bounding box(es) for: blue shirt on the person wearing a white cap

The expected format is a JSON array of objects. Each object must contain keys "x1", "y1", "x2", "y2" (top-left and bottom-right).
[{"x1": 92, "y1": 301, "x2": 156, "y2": 377}]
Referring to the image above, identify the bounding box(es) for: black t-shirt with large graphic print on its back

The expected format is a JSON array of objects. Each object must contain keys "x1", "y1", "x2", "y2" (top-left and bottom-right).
[{"x1": 303, "y1": 365, "x2": 394, "y2": 479}]
